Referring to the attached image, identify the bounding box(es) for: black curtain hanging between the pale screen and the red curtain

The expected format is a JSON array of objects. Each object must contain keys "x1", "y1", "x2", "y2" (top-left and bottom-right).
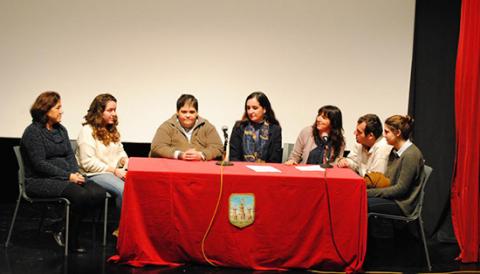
[{"x1": 409, "y1": 0, "x2": 460, "y2": 244}]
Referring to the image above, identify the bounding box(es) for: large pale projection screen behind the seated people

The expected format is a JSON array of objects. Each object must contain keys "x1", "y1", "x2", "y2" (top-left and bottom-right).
[{"x1": 0, "y1": 0, "x2": 415, "y2": 149}]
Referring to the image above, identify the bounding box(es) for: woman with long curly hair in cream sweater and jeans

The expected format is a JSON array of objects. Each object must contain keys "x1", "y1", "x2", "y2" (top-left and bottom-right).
[{"x1": 75, "y1": 93, "x2": 128, "y2": 215}]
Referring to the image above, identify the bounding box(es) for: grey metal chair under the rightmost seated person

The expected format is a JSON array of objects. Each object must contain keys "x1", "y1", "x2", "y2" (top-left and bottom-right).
[{"x1": 368, "y1": 165, "x2": 433, "y2": 271}]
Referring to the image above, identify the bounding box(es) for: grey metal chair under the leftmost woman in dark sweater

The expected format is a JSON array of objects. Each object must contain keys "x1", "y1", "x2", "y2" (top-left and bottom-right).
[{"x1": 5, "y1": 146, "x2": 110, "y2": 256}]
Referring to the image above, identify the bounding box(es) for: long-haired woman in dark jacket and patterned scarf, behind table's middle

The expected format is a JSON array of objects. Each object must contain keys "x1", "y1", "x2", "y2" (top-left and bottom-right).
[{"x1": 230, "y1": 91, "x2": 282, "y2": 163}]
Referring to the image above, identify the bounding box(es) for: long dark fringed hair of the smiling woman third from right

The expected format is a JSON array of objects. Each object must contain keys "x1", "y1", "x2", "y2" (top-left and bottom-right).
[{"x1": 312, "y1": 105, "x2": 345, "y2": 158}]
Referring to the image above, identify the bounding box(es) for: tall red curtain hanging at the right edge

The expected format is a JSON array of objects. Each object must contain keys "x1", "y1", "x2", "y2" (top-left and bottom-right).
[{"x1": 452, "y1": 0, "x2": 480, "y2": 263}]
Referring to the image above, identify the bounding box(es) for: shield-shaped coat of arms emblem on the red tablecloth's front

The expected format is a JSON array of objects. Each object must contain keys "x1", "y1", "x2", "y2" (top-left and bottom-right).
[{"x1": 228, "y1": 193, "x2": 255, "y2": 228}]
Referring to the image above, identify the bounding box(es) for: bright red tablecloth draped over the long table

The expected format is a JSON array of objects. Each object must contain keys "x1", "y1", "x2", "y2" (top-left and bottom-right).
[{"x1": 111, "y1": 158, "x2": 367, "y2": 271}]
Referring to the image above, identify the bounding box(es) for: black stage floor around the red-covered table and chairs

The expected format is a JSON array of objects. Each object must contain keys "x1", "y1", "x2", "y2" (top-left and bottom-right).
[{"x1": 0, "y1": 203, "x2": 480, "y2": 274}]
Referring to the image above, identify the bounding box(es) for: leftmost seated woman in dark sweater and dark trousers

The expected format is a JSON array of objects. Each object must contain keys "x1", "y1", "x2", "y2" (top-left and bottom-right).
[{"x1": 20, "y1": 91, "x2": 106, "y2": 253}]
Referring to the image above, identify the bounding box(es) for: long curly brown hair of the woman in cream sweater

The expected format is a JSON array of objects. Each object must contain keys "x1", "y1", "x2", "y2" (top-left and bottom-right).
[{"x1": 83, "y1": 93, "x2": 120, "y2": 146}]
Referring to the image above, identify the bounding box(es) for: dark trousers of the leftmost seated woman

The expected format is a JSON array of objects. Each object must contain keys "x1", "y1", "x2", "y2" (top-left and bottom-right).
[{"x1": 61, "y1": 181, "x2": 106, "y2": 248}]
